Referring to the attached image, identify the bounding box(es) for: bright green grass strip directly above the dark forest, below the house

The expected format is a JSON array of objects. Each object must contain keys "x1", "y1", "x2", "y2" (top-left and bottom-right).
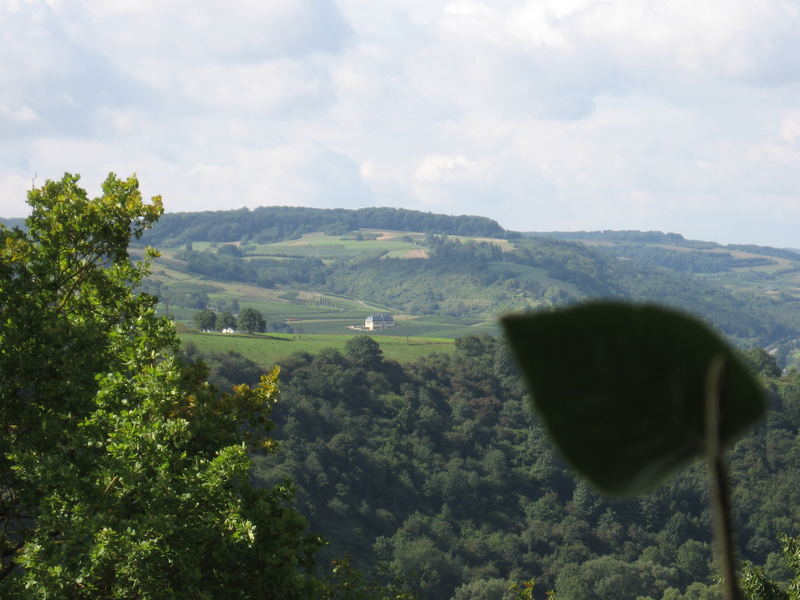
[{"x1": 180, "y1": 332, "x2": 455, "y2": 368}]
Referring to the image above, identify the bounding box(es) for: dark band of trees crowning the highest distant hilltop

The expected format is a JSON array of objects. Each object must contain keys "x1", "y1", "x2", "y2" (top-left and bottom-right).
[{"x1": 135, "y1": 206, "x2": 506, "y2": 246}]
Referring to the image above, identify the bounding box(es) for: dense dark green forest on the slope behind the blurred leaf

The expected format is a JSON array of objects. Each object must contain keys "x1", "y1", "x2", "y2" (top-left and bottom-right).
[{"x1": 241, "y1": 336, "x2": 800, "y2": 600}]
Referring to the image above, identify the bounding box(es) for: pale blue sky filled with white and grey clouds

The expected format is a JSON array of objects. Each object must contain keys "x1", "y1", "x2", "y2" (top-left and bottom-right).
[{"x1": 0, "y1": 0, "x2": 800, "y2": 248}]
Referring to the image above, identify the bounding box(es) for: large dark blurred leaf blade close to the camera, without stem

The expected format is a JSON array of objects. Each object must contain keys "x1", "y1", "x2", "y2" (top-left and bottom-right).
[{"x1": 502, "y1": 302, "x2": 765, "y2": 495}]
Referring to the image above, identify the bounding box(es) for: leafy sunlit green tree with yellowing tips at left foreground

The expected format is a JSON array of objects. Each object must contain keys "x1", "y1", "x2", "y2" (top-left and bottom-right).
[{"x1": 0, "y1": 174, "x2": 320, "y2": 599}]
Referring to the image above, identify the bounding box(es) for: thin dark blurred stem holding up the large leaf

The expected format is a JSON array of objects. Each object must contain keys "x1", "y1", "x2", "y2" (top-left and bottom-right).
[{"x1": 706, "y1": 355, "x2": 744, "y2": 600}]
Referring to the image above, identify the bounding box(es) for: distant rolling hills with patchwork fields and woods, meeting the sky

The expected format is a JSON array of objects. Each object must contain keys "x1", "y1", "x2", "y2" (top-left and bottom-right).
[{"x1": 122, "y1": 207, "x2": 800, "y2": 362}]
